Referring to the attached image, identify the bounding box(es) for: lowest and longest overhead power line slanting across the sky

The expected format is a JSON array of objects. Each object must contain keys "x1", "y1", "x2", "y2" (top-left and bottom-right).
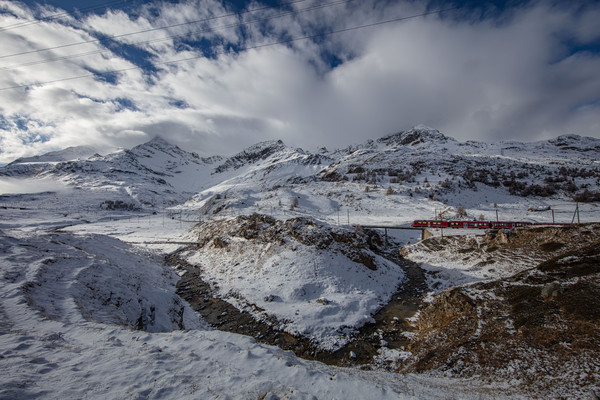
[{"x1": 0, "y1": 0, "x2": 497, "y2": 91}]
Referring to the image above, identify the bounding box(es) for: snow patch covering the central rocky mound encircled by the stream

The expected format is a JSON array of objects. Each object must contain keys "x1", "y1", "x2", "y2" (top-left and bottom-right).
[{"x1": 184, "y1": 225, "x2": 404, "y2": 350}]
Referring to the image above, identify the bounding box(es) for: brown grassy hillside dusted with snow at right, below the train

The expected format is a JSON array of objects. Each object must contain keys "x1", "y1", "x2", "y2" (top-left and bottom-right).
[{"x1": 398, "y1": 224, "x2": 600, "y2": 398}]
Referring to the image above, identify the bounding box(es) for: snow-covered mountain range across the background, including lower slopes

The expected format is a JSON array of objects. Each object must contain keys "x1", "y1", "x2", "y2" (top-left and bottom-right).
[{"x1": 0, "y1": 125, "x2": 600, "y2": 219}]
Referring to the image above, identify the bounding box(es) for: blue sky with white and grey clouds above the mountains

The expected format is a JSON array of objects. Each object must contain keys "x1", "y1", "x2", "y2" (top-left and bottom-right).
[{"x1": 0, "y1": 0, "x2": 600, "y2": 163}]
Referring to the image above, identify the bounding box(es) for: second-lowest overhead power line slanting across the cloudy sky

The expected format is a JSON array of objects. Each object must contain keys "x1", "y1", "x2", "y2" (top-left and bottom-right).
[{"x1": 0, "y1": 0, "x2": 350, "y2": 71}]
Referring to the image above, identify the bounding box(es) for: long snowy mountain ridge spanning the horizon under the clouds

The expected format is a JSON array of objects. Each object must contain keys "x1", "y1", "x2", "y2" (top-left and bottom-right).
[{"x1": 0, "y1": 125, "x2": 600, "y2": 211}]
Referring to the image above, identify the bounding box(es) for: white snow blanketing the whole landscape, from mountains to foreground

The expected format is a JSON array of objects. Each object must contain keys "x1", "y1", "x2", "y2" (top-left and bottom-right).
[{"x1": 0, "y1": 130, "x2": 600, "y2": 399}]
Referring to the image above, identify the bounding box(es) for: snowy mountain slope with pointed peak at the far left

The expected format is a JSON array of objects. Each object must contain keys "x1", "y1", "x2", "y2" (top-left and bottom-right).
[{"x1": 0, "y1": 137, "x2": 220, "y2": 208}]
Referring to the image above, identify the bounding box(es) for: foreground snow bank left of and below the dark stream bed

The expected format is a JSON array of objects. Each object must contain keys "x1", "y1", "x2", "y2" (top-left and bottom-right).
[{"x1": 0, "y1": 220, "x2": 510, "y2": 399}]
